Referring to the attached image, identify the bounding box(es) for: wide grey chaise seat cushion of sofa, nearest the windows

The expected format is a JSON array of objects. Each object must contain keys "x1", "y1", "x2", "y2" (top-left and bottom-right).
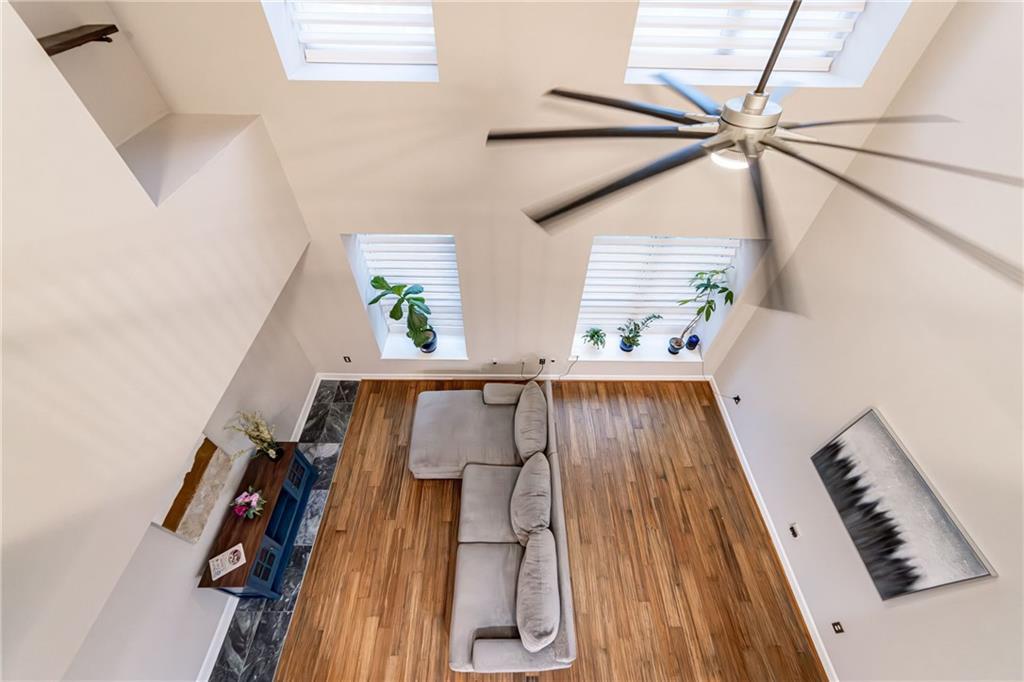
[{"x1": 409, "y1": 390, "x2": 519, "y2": 478}]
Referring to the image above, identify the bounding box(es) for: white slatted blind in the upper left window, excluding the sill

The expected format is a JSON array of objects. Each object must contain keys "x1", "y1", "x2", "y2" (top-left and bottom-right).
[{"x1": 288, "y1": 0, "x2": 437, "y2": 66}]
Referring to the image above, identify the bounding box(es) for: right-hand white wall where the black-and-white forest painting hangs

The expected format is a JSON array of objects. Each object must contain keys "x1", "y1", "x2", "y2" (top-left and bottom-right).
[{"x1": 715, "y1": 2, "x2": 1024, "y2": 680}]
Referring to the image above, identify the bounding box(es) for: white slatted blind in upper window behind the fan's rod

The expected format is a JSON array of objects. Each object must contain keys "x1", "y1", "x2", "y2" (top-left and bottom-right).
[{"x1": 629, "y1": 0, "x2": 865, "y2": 72}]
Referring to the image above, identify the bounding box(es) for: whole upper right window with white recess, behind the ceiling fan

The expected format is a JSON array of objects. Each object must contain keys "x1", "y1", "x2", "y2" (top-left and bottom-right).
[{"x1": 627, "y1": 0, "x2": 909, "y2": 86}]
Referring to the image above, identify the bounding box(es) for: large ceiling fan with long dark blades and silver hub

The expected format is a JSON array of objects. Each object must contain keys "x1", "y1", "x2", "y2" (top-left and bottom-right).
[{"x1": 487, "y1": 0, "x2": 1024, "y2": 309}]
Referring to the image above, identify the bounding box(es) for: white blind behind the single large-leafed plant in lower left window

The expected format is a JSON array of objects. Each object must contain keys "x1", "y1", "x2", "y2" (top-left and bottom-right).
[{"x1": 355, "y1": 235, "x2": 463, "y2": 334}]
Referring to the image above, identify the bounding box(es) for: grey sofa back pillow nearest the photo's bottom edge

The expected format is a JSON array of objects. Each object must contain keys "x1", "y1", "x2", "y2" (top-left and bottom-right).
[{"x1": 515, "y1": 529, "x2": 561, "y2": 652}]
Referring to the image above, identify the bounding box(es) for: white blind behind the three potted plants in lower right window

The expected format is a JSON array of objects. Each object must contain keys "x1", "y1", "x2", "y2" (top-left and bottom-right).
[{"x1": 577, "y1": 237, "x2": 739, "y2": 334}]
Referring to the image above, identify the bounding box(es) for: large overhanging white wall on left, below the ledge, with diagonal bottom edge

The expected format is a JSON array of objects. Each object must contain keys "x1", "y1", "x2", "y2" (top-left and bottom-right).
[{"x1": 0, "y1": 4, "x2": 308, "y2": 679}]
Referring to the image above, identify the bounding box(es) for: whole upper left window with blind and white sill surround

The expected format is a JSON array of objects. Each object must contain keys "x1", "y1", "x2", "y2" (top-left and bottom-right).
[{"x1": 263, "y1": 0, "x2": 437, "y2": 81}]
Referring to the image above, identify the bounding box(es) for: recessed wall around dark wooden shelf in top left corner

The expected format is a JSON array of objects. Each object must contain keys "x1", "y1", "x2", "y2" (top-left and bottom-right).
[{"x1": 11, "y1": 0, "x2": 169, "y2": 145}]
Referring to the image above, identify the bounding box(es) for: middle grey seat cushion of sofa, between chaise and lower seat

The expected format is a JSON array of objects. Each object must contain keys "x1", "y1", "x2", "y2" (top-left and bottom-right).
[{"x1": 459, "y1": 458, "x2": 524, "y2": 543}]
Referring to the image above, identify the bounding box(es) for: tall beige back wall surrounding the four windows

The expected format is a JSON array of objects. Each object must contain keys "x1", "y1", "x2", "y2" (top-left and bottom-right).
[{"x1": 105, "y1": 0, "x2": 949, "y2": 376}]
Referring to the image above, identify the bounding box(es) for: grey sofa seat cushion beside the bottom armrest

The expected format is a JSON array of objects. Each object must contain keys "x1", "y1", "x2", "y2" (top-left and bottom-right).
[{"x1": 449, "y1": 543, "x2": 523, "y2": 672}]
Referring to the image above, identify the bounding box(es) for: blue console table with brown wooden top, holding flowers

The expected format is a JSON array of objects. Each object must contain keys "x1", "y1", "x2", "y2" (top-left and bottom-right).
[{"x1": 199, "y1": 442, "x2": 316, "y2": 599}]
